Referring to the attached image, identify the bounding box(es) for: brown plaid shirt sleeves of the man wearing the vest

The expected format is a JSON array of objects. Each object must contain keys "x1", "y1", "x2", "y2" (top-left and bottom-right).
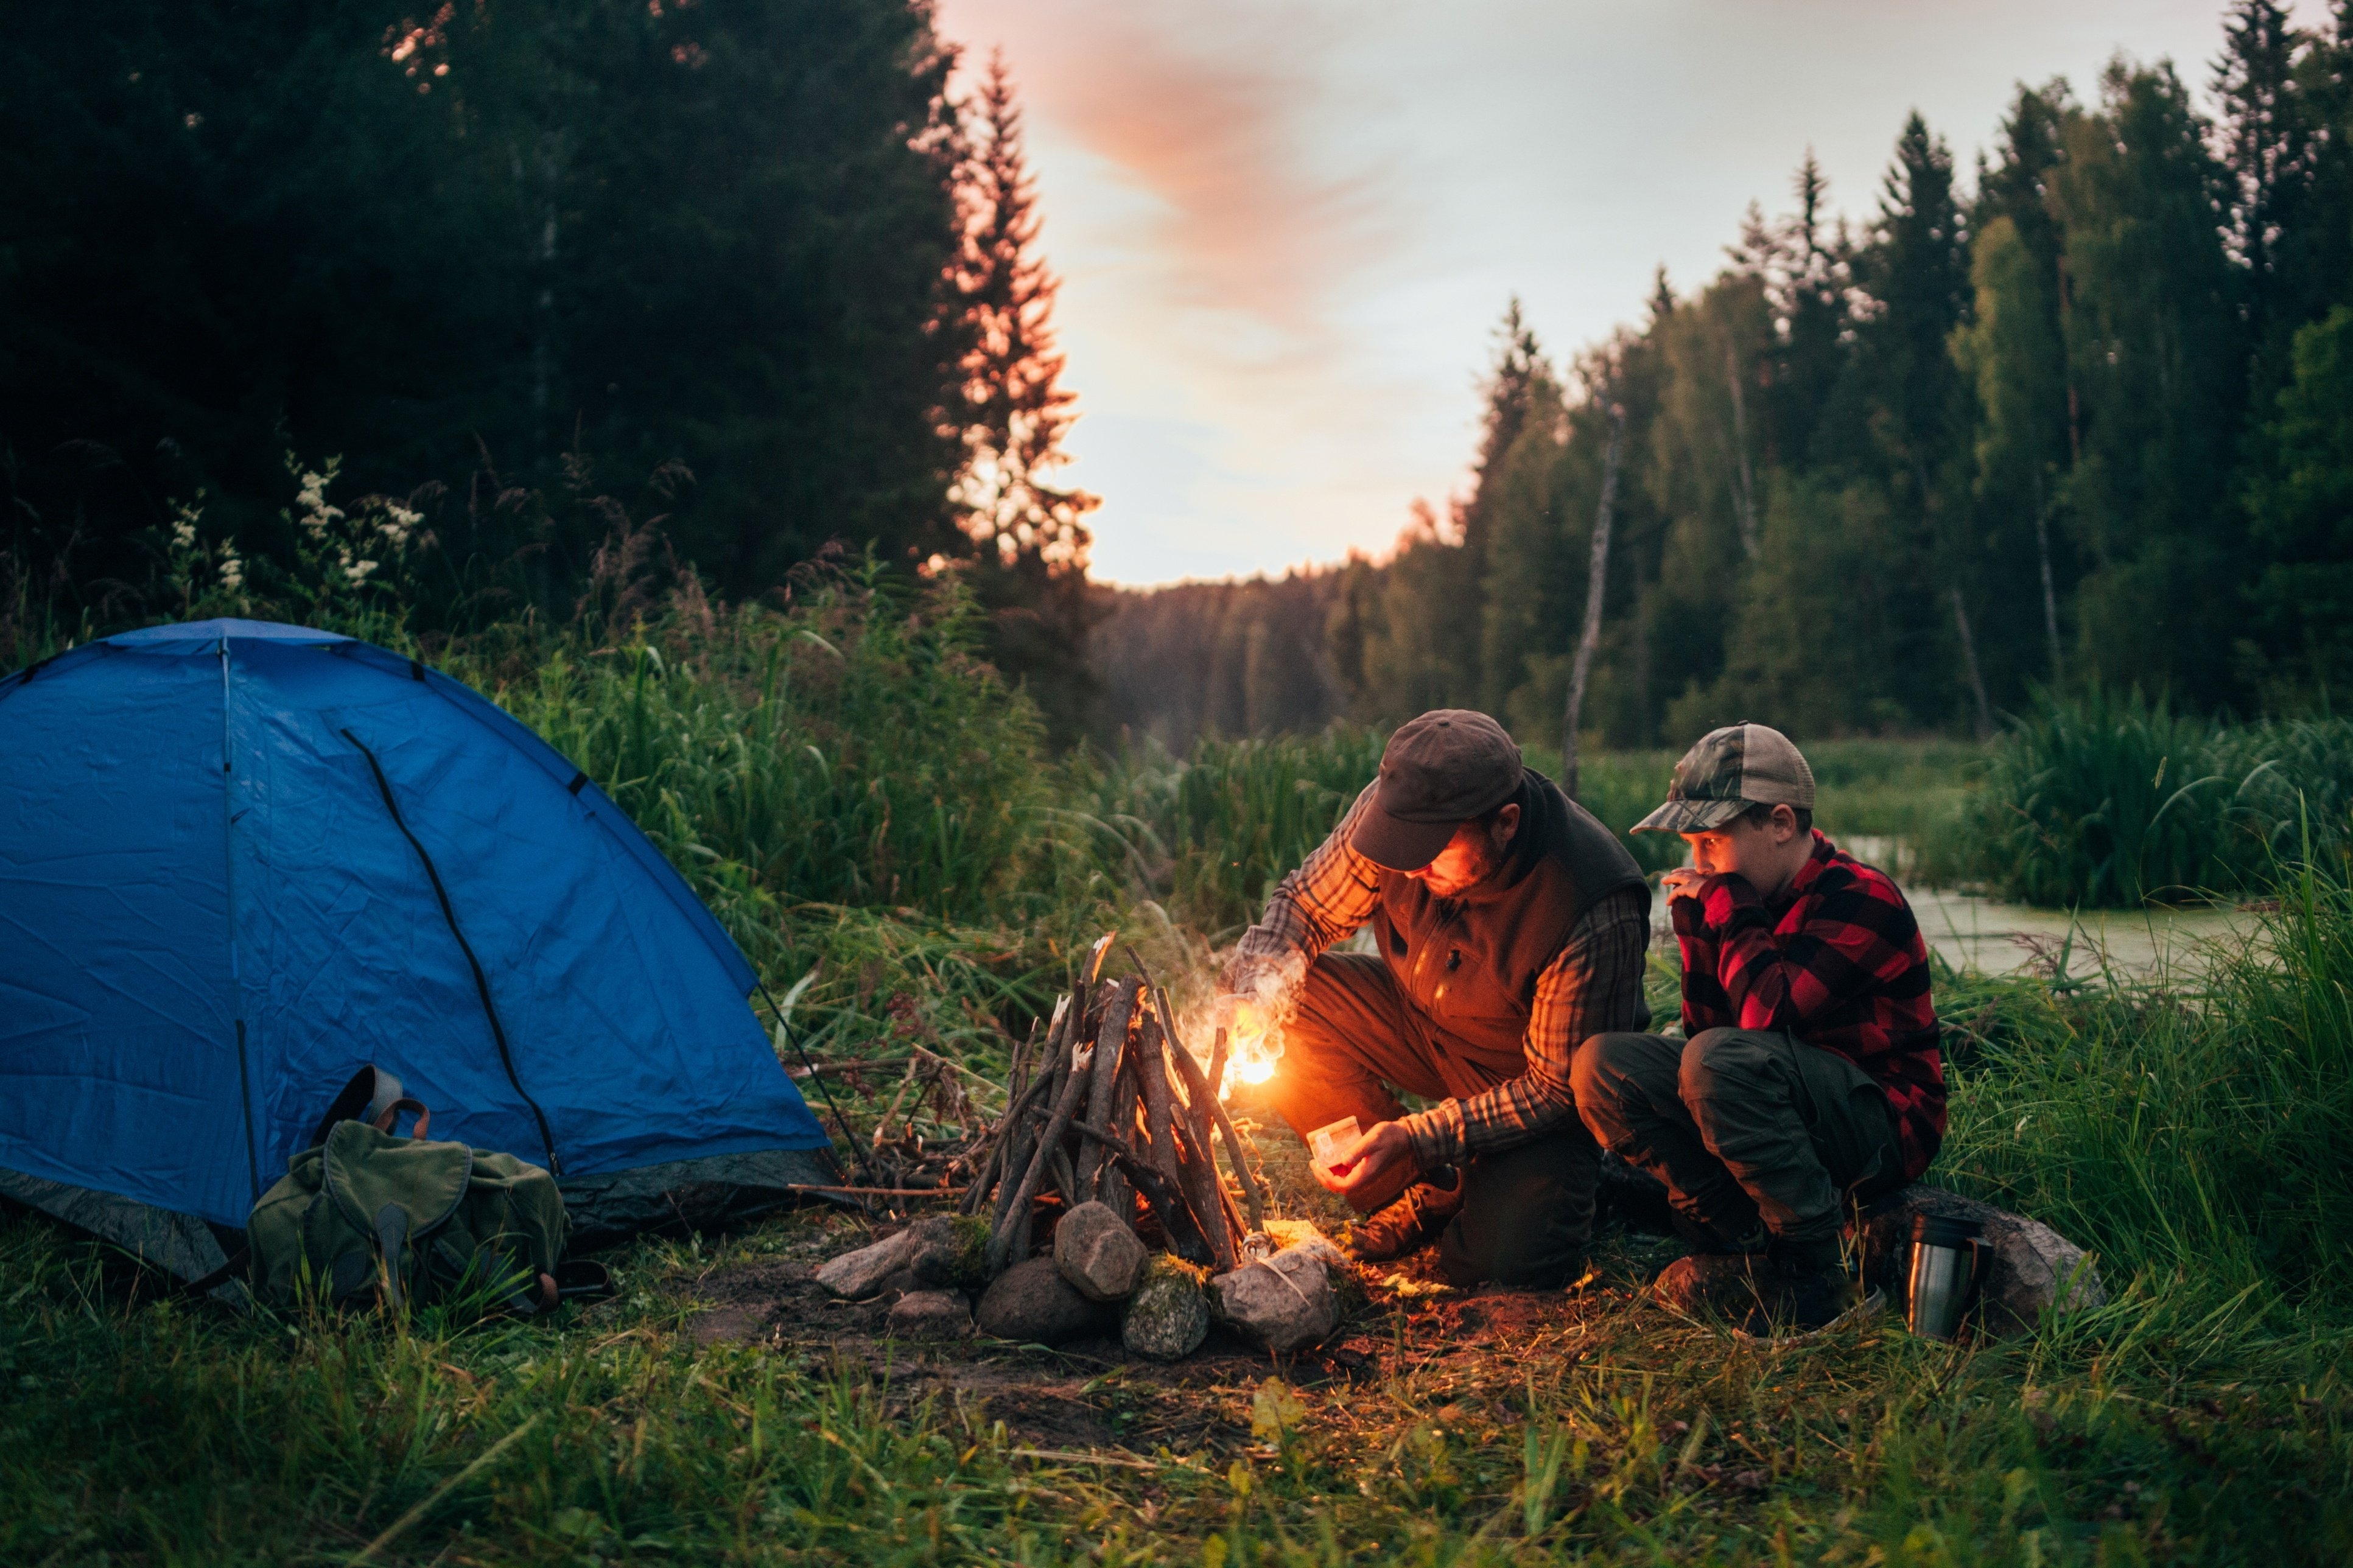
[{"x1": 1226, "y1": 789, "x2": 1649, "y2": 1170}]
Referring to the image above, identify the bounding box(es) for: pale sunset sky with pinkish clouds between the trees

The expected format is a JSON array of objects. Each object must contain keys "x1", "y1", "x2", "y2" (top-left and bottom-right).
[{"x1": 936, "y1": 0, "x2": 2325, "y2": 584}]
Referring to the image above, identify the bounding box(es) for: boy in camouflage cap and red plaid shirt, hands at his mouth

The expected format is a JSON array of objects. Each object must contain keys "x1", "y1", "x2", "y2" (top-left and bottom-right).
[{"x1": 1572, "y1": 723, "x2": 1943, "y2": 1332}]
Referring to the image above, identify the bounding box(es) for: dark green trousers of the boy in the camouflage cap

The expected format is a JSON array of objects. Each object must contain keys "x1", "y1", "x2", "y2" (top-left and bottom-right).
[{"x1": 1569, "y1": 1029, "x2": 1904, "y2": 1243}]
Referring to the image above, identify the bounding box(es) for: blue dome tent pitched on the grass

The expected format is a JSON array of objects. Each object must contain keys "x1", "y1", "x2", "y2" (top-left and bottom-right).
[{"x1": 0, "y1": 619, "x2": 838, "y2": 1278}]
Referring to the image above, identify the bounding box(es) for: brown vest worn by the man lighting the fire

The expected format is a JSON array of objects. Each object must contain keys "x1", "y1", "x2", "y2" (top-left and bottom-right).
[{"x1": 1372, "y1": 768, "x2": 1643, "y2": 1052}]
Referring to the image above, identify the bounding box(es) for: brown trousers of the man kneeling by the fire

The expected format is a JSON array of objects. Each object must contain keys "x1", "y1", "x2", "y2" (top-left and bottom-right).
[{"x1": 1259, "y1": 953, "x2": 1600, "y2": 1286}]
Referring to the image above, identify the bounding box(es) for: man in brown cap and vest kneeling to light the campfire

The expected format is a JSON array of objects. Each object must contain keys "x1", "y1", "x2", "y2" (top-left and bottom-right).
[{"x1": 1221, "y1": 709, "x2": 1649, "y2": 1286}]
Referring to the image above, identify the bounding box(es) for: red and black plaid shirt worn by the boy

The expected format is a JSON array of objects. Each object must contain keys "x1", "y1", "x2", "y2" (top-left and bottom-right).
[{"x1": 1668, "y1": 828, "x2": 1943, "y2": 1180}]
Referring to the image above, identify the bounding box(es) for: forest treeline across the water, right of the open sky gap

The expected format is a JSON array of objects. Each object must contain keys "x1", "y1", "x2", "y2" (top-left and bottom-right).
[{"x1": 1096, "y1": 0, "x2": 2353, "y2": 746}]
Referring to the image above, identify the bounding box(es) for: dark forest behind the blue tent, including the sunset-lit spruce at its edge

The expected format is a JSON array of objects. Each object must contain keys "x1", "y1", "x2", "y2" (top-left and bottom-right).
[{"x1": 0, "y1": 0, "x2": 1092, "y2": 730}]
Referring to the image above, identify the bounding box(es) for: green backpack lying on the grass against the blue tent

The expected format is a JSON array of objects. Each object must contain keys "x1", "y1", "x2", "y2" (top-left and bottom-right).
[{"x1": 245, "y1": 1069, "x2": 583, "y2": 1316}]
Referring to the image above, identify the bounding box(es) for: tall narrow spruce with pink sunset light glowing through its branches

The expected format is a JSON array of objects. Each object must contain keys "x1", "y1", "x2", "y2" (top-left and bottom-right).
[{"x1": 953, "y1": 54, "x2": 1099, "y2": 740}]
